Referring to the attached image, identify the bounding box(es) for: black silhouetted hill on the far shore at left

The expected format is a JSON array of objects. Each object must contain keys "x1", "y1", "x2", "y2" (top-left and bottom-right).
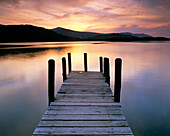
[{"x1": 0, "y1": 25, "x2": 77, "y2": 42}]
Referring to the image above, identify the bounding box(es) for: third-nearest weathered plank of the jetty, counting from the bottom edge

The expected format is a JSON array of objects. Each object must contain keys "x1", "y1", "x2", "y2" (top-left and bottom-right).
[{"x1": 42, "y1": 114, "x2": 126, "y2": 121}]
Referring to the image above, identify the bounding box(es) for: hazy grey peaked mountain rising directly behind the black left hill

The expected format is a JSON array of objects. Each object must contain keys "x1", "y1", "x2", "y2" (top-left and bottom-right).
[{"x1": 51, "y1": 27, "x2": 100, "y2": 39}]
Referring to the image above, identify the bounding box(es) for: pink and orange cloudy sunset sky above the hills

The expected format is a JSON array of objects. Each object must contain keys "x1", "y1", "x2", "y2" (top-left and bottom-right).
[{"x1": 0, "y1": 0, "x2": 170, "y2": 37}]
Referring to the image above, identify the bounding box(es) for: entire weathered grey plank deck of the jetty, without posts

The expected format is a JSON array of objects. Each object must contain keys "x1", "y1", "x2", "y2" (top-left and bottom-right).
[{"x1": 33, "y1": 71, "x2": 133, "y2": 136}]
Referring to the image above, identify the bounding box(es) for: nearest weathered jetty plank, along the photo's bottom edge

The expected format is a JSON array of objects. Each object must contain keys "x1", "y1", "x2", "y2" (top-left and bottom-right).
[{"x1": 34, "y1": 127, "x2": 133, "y2": 135}]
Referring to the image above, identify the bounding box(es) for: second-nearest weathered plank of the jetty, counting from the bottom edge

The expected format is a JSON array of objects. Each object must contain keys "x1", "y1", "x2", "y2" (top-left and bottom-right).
[{"x1": 38, "y1": 121, "x2": 128, "y2": 127}]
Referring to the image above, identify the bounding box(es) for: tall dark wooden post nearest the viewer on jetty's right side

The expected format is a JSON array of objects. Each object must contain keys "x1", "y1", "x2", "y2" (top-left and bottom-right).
[{"x1": 114, "y1": 58, "x2": 122, "y2": 102}]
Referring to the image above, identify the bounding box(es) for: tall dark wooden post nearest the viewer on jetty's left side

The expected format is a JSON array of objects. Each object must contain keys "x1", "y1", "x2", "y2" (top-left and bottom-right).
[{"x1": 48, "y1": 59, "x2": 55, "y2": 105}]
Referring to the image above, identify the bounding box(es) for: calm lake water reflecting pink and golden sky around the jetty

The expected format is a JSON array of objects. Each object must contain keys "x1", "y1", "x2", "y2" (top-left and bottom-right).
[{"x1": 0, "y1": 42, "x2": 170, "y2": 136}]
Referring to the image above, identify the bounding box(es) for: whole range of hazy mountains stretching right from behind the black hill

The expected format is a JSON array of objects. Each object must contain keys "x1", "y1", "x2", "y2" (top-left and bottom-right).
[{"x1": 51, "y1": 27, "x2": 169, "y2": 41}]
